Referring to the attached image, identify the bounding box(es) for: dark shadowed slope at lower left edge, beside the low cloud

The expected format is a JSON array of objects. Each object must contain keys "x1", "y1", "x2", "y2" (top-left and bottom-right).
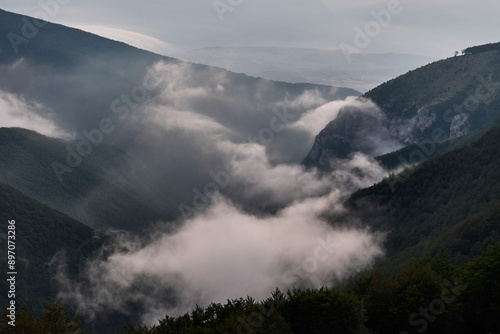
[{"x1": 0, "y1": 184, "x2": 104, "y2": 312}]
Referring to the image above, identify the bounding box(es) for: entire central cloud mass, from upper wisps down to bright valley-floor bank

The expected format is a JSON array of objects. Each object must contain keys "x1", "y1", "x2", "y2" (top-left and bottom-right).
[{"x1": 34, "y1": 63, "x2": 387, "y2": 324}]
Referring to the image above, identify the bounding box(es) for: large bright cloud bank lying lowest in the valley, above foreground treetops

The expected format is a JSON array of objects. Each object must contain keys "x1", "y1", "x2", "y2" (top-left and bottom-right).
[{"x1": 58, "y1": 191, "x2": 382, "y2": 324}]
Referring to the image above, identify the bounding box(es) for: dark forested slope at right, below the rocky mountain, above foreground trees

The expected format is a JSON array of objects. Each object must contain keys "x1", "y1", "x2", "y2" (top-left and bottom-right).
[{"x1": 346, "y1": 127, "x2": 500, "y2": 267}]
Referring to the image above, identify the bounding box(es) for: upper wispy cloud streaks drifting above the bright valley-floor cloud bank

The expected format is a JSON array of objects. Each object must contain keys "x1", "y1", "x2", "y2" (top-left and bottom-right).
[{"x1": 133, "y1": 62, "x2": 390, "y2": 212}]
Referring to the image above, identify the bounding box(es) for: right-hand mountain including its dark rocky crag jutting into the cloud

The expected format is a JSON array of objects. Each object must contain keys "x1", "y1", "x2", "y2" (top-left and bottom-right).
[{"x1": 304, "y1": 42, "x2": 500, "y2": 170}]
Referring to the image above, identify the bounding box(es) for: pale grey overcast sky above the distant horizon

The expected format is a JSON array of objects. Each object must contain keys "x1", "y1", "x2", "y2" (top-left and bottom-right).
[{"x1": 0, "y1": 0, "x2": 500, "y2": 57}]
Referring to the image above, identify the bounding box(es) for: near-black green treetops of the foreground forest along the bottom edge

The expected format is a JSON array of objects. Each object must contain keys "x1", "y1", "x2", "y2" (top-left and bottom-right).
[{"x1": 0, "y1": 242, "x2": 500, "y2": 334}]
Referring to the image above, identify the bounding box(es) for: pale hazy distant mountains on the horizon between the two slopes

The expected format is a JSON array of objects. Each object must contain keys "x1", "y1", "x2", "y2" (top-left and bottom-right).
[{"x1": 181, "y1": 47, "x2": 437, "y2": 92}]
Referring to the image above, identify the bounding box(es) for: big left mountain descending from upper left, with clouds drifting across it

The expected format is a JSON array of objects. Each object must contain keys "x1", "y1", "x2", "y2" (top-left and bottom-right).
[{"x1": 0, "y1": 10, "x2": 360, "y2": 230}]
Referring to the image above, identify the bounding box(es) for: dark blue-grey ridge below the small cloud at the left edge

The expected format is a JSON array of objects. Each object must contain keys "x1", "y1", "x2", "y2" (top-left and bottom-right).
[{"x1": 0, "y1": 128, "x2": 179, "y2": 230}]
